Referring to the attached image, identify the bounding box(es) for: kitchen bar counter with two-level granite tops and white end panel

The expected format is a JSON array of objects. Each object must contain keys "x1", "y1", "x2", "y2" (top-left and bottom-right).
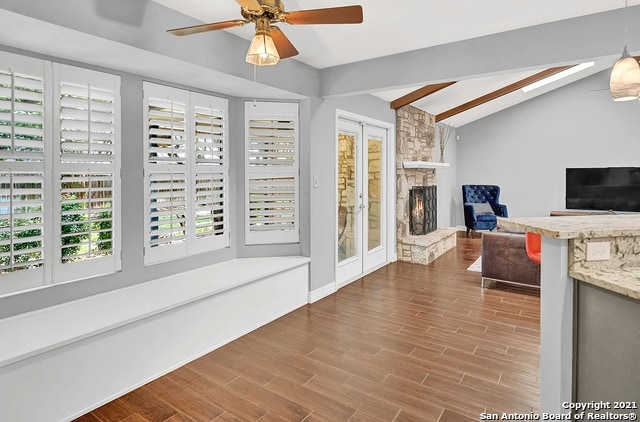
[{"x1": 498, "y1": 214, "x2": 640, "y2": 413}]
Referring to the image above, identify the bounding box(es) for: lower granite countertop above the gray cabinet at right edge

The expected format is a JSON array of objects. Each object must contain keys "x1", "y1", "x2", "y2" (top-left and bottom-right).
[{"x1": 569, "y1": 267, "x2": 640, "y2": 300}]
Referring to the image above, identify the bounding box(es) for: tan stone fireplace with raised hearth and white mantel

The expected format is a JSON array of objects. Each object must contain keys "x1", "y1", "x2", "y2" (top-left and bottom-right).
[{"x1": 396, "y1": 105, "x2": 456, "y2": 264}]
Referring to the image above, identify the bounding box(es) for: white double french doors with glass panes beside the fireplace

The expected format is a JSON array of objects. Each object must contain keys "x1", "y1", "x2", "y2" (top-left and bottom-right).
[{"x1": 336, "y1": 118, "x2": 387, "y2": 287}]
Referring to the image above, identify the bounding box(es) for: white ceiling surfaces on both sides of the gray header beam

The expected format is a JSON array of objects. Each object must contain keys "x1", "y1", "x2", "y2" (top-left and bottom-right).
[{"x1": 153, "y1": 0, "x2": 640, "y2": 126}]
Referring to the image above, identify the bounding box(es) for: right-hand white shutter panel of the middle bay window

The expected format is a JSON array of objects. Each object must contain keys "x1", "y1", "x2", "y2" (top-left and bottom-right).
[{"x1": 190, "y1": 93, "x2": 229, "y2": 252}]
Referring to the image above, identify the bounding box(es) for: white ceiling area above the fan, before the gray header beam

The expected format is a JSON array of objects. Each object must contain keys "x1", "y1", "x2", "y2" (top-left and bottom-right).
[{"x1": 153, "y1": 0, "x2": 640, "y2": 69}]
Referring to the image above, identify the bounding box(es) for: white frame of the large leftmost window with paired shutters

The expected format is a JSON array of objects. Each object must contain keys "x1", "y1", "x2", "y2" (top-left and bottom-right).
[{"x1": 0, "y1": 52, "x2": 121, "y2": 295}]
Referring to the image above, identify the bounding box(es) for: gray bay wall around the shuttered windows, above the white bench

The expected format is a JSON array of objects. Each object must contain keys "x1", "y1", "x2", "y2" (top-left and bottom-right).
[{"x1": 0, "y1": 66, "x2": 318, "y2": 318}]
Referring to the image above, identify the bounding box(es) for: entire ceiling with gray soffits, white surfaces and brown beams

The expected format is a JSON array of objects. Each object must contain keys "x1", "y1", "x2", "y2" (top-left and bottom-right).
[{"x1": 0, "y1": 0, "x2": 640, "y2": 126}]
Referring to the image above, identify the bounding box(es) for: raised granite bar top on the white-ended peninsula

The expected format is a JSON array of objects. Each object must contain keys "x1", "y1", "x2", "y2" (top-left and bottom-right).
[{"x1": 498, "y1": 214, "x2": 640, "y2": 239}]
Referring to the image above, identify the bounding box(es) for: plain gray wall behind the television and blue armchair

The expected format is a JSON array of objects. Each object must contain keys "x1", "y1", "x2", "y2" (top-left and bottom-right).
[{"x1": 453, "y1": 71, "x2": 640, "y2": 226}]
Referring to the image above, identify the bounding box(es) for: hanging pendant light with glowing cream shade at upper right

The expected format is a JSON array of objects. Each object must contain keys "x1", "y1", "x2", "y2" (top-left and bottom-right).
[{"x1": 609, "y1": 0, "x2": 640, "y2": 101}]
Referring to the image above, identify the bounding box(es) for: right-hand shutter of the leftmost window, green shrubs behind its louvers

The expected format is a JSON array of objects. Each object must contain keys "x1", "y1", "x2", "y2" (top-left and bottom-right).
[{"x1": 55, "y1": 65, "x2": 121, "y2": 281}]
